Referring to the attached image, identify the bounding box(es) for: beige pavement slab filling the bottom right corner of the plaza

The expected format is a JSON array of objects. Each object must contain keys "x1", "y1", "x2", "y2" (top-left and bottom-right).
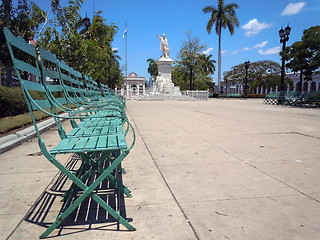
[{"x1": 181, "y1": 195, "x2": 320, "y2": 240}]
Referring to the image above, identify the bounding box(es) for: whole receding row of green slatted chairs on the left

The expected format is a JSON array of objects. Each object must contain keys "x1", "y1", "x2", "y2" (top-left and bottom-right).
[{"x1": 4, "y1": 28, "x2": 135, "y2": 238}]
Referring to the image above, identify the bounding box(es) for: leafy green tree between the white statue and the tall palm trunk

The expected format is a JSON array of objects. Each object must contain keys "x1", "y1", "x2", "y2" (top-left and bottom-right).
[{"x1": 172, "y1": 32, "x2": 215, "y2": 90}]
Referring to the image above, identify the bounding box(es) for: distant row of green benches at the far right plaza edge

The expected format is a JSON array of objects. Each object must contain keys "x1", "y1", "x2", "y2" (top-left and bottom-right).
[{"x1": 264, "y1": 91, "x2": 320, "y2": 107}]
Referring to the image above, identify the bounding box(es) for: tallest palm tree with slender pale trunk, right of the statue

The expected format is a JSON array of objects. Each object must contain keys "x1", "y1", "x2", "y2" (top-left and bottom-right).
[{"x1": 202, "y1": 0, "x2": 239, "y2": 92}]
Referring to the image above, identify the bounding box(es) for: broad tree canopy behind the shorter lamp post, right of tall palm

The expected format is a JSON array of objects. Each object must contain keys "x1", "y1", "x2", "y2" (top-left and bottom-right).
[{"x1": 224, "y1": 60, "x2": 293, "y2": 93}]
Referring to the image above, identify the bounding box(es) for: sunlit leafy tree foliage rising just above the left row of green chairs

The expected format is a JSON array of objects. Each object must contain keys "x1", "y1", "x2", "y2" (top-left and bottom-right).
[{"x1": 38, "y1": 0, "x2": 123, "y2": 88}]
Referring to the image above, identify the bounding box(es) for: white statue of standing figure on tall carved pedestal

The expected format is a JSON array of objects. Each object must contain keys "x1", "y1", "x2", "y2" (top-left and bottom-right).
[{"x1": 155, "y1": 34, "x2": 181, "y2": 95}]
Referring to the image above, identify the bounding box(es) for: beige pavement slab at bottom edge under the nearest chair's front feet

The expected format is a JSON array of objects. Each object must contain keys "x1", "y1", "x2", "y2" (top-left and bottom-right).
[{"x1": 11, "y1": 202, "x2": 196, "y2": 240}]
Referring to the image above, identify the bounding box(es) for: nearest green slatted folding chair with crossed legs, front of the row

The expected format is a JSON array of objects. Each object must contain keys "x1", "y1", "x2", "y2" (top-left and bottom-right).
[{"x1": 4, "y1": 28, "x2": 135, "y2": 238}]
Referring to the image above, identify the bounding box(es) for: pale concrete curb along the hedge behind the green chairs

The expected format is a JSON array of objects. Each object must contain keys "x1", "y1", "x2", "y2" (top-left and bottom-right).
[{"x1": 0, "y1": 113, "x2": 68, "y2": 154}]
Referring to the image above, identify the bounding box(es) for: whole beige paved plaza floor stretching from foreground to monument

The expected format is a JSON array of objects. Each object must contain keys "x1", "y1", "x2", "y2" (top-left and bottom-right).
[{"x1": 0, "y1": 99, "x2": 320, "y2": 240}]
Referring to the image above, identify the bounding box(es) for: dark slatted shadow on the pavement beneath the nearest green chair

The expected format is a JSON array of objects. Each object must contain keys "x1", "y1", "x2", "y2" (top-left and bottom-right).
[{"x1": 24, "y1": 155, "x2": 132, "y2": 238}]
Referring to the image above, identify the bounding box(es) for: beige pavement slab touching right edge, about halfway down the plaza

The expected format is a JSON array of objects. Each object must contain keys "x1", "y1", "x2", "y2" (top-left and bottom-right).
[{"x1": 211, "y1": 133, "x2": 320, "y2": 162}]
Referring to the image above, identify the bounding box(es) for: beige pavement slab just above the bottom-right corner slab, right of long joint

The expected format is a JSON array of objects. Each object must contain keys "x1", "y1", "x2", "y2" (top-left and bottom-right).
[{"x1": 161, "y1": 163, "x2": 298, "y2": 202}]
